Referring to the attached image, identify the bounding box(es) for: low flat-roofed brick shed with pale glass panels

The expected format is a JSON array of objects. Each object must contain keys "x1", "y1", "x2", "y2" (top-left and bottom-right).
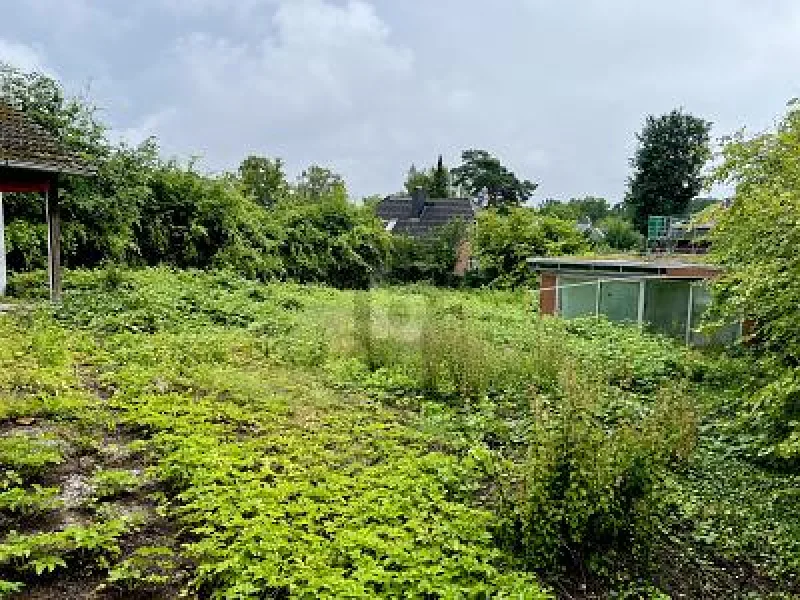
[{"x1": 529, "y1": 257, "x2": 741, "y2": 346}]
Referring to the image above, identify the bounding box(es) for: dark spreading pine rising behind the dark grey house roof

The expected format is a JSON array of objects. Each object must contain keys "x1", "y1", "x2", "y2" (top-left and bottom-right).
[{"x1": 452, "y1": 150, "x2": 537, "y2": 207}]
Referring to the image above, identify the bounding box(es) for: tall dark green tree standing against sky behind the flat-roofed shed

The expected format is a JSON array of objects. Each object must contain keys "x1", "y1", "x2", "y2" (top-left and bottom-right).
[{"x1": 625, "y1": 110, "x2": 711, "y2": 233}]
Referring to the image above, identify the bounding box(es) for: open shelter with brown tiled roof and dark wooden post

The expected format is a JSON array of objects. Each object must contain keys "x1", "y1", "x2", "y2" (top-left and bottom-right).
[{"x1": 0, "y1": 101, "x2": 94, "y2": 301}]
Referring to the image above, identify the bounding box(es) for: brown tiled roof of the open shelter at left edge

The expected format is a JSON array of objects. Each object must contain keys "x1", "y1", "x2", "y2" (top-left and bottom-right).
[{"x1": 0, "y1": 101, "x2": 94, "y2": 175}]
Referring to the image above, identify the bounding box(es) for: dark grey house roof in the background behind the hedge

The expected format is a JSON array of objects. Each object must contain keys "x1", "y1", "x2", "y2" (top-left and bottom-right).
[{"x1": 375, "y1": 196, "x2": 475, "y2": 237}]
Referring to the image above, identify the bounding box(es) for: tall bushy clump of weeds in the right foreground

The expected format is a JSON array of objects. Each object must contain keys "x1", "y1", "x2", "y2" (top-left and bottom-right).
[{"x1": 501, "y1": 380, "x2": 696, "y2": 573}]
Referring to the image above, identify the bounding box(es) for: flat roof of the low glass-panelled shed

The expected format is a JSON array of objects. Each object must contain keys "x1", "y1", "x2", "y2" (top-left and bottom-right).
[{"x1": 528, "y1": 256, "x2": 722, "y2": 280}]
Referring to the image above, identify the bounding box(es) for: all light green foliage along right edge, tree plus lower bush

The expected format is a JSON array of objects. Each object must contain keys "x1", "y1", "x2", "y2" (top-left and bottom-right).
[{"x1": 712, "y1": 103, "x2": 800, "y2": 464}]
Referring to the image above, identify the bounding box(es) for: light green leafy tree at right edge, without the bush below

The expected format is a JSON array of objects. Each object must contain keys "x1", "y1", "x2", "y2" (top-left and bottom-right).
[{"x1": 712, "y1": 103, "x2": 800, "y2": 364}]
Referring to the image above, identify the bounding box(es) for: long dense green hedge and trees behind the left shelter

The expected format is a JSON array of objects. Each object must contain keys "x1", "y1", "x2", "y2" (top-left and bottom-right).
[{"x1": 0, "y1": 66, "x2": 388, "y2": 287}]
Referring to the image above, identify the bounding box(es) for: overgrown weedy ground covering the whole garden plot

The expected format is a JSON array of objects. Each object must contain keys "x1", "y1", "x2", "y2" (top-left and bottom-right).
[{"x1": 0, "y1": 270, "x2": 800, "y2": 599}]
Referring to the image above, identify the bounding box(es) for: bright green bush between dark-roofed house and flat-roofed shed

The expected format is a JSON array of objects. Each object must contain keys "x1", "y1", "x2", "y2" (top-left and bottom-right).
[{"x1": 473, "y1": 208, "x2": 588, "y2": 287}]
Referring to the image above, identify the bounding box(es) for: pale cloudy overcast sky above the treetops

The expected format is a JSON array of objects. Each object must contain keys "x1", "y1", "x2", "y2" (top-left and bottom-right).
[{"x1": 0, "y1": 0, "x2": 800, "y2": 201}]
